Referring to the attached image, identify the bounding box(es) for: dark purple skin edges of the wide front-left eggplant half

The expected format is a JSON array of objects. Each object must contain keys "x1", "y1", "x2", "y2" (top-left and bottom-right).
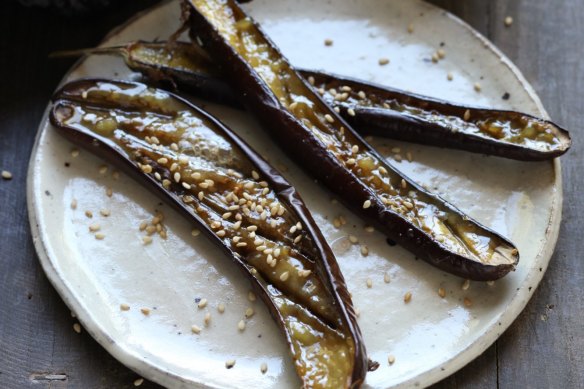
[{"x1": 49, "y1": 79, "x2": 370, "y2": 387}]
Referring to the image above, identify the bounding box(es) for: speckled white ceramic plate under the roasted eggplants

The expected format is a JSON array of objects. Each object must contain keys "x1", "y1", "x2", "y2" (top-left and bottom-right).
[{"x1": 28, "y1": 0, "x2": 562, "y2": 388}]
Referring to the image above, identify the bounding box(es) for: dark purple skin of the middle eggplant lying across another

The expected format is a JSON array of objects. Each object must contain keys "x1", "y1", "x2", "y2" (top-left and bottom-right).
[{"x1": 184, "y1": 1, "x2": 519, "y2": 281}]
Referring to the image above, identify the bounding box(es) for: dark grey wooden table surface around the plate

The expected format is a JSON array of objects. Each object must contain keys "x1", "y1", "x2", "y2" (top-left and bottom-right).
[{"x1": 0, "y1": 0, "x2": 584, "y2": 389}]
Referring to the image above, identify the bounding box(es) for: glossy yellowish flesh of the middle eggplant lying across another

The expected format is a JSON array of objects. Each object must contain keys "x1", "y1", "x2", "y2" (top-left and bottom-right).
[{"x1": 191, "y1": 0, "x2": 517, "y2": 265}]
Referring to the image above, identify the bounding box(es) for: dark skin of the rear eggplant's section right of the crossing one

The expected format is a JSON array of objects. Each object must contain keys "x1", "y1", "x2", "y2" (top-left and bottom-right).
[{"x1": 301, "y1": 70, "x2": 571, "y2": 161}]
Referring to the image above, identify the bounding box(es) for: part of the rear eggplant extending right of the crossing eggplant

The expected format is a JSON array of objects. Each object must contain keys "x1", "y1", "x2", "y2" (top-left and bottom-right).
[{"x1": 303, "y1": 71, "x2": 571, "y2": 160}]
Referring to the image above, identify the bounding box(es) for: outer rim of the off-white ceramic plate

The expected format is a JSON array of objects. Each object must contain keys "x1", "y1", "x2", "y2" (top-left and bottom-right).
[{"x1": 26, "y1": 0, "x2": 563, "y2": 388}]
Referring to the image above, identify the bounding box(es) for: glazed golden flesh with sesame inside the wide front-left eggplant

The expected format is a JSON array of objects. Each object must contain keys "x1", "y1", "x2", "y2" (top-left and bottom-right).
[{"x1": 53, "y1": 82, "x2": 355, "y2": 388}]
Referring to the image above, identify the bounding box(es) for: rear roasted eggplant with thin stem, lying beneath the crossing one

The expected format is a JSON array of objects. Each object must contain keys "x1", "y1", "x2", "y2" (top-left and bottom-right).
[{"x1": 61, "y1": 41, "x2": 571, "y2": 161}]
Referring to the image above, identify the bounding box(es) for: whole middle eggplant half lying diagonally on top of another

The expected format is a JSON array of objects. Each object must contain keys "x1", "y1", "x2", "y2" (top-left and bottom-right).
[{"x1": 189, "y1": 0, "x2": 519, "y2": 280}]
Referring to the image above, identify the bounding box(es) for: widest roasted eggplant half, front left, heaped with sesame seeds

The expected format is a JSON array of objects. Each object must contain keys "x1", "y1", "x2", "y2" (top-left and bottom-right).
[{"x1": 50, "y1": 80, "x2": 367, "y2": 388}]
